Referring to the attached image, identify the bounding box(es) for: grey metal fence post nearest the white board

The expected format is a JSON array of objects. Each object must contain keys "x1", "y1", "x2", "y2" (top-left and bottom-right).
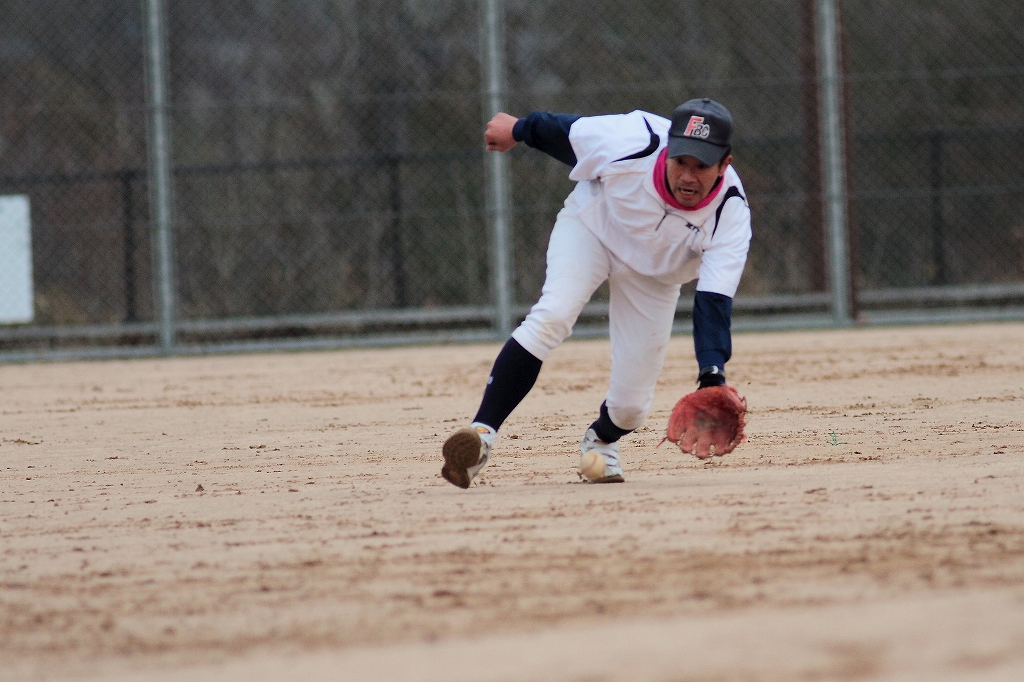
[{"x1": 142, "y1": 0, "x2": 175, "y2": 353}]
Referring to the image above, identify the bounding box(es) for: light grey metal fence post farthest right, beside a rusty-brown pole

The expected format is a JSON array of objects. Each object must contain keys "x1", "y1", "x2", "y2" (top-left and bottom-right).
[{"x1": 818, "y1": 0, "x2": 853, "y2": 325}]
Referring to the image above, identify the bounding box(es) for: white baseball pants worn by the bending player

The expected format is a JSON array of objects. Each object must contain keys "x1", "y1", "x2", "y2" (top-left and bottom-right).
[{"x1": 512, "y1": 208, "x2": 680, "y2": 430}]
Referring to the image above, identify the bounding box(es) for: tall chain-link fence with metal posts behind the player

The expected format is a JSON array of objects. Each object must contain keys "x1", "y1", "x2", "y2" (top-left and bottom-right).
[{"x1": 0, "y1": 0, "x2": 1024, "y2": 358}]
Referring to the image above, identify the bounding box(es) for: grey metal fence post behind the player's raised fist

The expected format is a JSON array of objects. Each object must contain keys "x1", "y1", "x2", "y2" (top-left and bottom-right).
[{"x1": 481, "y1": 0, "x2": 512, "y2": 338}]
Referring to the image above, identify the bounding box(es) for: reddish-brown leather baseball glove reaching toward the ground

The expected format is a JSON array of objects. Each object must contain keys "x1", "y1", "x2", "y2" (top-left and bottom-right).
[{"x1": 662, "y1": 386, "x2": 746, "y2": 460}]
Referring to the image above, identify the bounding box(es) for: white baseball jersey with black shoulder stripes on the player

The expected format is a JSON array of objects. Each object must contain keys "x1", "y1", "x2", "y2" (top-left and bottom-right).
[{"x1": 565, "y1": 111, "x2": 751, "y2": 298}]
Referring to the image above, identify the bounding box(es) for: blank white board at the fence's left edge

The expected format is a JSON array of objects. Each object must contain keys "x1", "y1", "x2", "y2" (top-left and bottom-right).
[{"x1": 0, "y1": 195, "x2": 33, "y2": 325}]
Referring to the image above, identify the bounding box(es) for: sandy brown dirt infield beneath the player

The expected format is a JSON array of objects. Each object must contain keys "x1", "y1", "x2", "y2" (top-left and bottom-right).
[{"x1": 0, "y1": 324, "x2": 1024, "y2": 682}]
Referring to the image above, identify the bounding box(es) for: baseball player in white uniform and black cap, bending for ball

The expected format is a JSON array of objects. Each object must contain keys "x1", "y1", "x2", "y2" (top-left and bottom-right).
[{"x1": 441, "y1": 98, "x2": 751, "y2": 487}]
